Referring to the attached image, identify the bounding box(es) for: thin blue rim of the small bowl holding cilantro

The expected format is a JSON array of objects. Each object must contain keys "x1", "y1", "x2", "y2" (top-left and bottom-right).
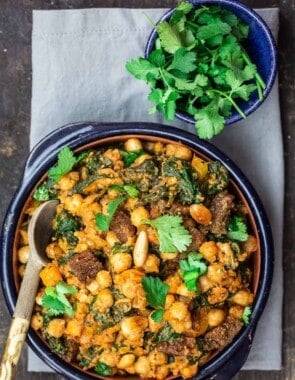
[{"x1": 144, "y1": 0, "x2": 278, "y2": 125}]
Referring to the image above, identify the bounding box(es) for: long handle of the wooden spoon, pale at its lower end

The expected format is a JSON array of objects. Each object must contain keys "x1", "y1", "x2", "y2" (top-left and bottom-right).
[{"x1": 0, "y1": 258, "x2": 42, "y2": 380}]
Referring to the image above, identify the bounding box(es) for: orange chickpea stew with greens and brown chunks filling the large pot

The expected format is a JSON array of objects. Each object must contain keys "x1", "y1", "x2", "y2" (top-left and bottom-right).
[{"x1": 18, "y1": 137, "x2": 258, "y2": 379}]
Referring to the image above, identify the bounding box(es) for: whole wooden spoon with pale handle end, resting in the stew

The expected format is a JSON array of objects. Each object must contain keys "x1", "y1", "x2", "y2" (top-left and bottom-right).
[{"x1": 0, "y1": 200, "x2": 58, "y2": 380}]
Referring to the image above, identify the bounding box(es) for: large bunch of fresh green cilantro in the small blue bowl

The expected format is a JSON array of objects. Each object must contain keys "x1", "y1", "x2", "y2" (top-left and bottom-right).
[{"x1": 126, "y1": 2, "x2": 266, "y2": 139}]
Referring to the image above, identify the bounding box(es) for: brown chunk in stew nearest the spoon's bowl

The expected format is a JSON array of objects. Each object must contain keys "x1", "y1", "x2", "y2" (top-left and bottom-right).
[{"x1": 68, "y1": 250, "x2": 103, "y2": 282}]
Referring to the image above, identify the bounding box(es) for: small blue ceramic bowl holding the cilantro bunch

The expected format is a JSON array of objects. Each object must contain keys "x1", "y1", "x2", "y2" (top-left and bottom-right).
[{"x1": 145, "y1": 0, "x2": 277, "y2": 125}]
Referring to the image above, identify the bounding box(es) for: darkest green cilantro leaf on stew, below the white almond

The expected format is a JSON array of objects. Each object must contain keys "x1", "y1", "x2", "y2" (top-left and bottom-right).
[{"x1": 141, "y1": 276, "x2": 169, "y2": 322}]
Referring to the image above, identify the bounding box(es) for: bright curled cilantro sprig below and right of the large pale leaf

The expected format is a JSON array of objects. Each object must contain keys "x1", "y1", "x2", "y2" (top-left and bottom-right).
[{"x1": 179, "y1": 252, "x2": 207, "y2": 291}]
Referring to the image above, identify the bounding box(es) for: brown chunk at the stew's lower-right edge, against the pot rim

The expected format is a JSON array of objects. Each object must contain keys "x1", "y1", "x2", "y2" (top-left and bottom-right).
[{"x1": 204, "y1": 316, "x2": 243, "y2": 351}]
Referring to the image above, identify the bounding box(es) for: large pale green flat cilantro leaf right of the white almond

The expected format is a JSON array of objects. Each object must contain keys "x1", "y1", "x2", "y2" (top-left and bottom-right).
[{"x1": 144, "y1": 215, "x2": 192, "y2": 253}]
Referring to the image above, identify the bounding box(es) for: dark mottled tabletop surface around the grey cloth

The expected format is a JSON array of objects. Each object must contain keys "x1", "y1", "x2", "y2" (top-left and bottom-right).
[{"x1": 0, "y1": 0, "x2": 295, "y2": 380}]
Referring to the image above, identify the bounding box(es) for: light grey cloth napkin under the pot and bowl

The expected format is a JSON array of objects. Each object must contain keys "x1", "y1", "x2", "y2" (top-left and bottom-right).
[{"x1": 29, "y1": 8, "x2": 284, "y2": 372}]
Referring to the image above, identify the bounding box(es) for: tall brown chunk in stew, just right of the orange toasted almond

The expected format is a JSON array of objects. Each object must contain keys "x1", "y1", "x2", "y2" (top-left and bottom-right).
[{"x1": 209, "y1": 191, "x2": 234, "y2": 235}]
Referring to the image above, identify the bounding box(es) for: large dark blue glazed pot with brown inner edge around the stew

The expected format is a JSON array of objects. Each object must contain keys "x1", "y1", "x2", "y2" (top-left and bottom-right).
[{"x1": 0, "y1": 123, "x2": 273, "y2": 380}]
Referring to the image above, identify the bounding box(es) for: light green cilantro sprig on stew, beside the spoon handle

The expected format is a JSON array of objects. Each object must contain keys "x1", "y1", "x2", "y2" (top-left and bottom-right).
[{"x1": 41, "y1": 281, "x2": 77, "y2": 316}]
